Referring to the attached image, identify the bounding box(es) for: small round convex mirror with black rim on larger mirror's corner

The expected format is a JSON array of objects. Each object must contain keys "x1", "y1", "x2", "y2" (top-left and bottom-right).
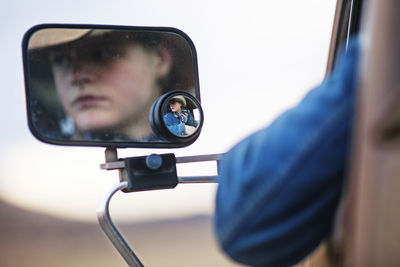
[{"x1": 150, "y1": 91, "x2": 203, "y2": 145}]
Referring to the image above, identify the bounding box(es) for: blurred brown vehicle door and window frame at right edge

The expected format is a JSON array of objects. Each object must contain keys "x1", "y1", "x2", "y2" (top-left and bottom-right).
[{"x1": 301, "y1": 0, "x2": 400, "y2": 266}]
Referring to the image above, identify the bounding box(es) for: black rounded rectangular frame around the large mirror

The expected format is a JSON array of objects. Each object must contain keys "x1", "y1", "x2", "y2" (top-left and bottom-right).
[{"x1": 22, "y1": 24, "x2": 200, "y2": 148}]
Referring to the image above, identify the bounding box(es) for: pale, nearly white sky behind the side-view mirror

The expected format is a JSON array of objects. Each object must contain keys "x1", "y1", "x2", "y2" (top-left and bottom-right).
[{"x1": 0, "y1": 0, "x2": 336, "y2": 224}]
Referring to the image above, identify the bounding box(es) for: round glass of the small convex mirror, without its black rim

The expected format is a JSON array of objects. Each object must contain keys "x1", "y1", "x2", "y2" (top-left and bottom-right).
[{"x1": 163, "y1": 94, "x2": 202, "y2": 137}]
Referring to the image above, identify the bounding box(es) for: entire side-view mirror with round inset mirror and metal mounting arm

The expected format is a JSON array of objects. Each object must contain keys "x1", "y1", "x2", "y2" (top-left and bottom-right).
[{"x1": 23, "y1": 24, "x2": 214, "y2": 266}]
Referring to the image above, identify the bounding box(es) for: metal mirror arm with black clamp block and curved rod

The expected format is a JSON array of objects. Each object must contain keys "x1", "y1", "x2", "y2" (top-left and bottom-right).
[{"x1": 97, "y1": 148, "x2": 222, "y2": 267}]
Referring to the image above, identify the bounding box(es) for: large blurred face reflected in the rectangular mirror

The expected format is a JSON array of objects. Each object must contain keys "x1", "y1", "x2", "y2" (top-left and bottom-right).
[{"x1": 52, "y1": 44, "x2": 170, "y2": 138}]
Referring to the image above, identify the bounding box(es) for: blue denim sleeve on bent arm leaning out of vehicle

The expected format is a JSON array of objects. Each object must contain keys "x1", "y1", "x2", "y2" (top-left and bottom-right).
[{"x1": 214, "y1": 40, "x2": 359, "y2": 266}]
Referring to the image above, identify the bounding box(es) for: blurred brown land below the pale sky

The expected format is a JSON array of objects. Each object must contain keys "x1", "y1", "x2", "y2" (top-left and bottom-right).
[{"x1": 0, "y1": 201, "x2": 238, "y2": 267}]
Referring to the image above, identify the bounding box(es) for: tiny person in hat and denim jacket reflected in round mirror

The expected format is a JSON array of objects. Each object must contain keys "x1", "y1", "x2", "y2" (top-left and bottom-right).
[{"x1": 164, "y1": 96, "x2": 198, "y2": 136}]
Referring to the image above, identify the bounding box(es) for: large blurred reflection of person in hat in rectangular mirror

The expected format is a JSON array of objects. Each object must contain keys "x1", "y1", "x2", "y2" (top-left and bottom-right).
[{"x1": 30, "y1": 29, "x2": 192, "y2": 140}]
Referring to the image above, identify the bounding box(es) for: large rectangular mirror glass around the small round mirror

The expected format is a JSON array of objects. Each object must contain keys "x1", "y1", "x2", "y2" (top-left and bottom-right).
[{"x1": 24, "y1": 25, "x2": 200, "y2": 147}]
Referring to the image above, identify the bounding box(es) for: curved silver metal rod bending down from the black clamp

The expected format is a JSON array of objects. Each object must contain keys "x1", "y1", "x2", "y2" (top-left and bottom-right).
[{"x1": 97, "y1": 182, "x2": 143, "y2": 267}]
